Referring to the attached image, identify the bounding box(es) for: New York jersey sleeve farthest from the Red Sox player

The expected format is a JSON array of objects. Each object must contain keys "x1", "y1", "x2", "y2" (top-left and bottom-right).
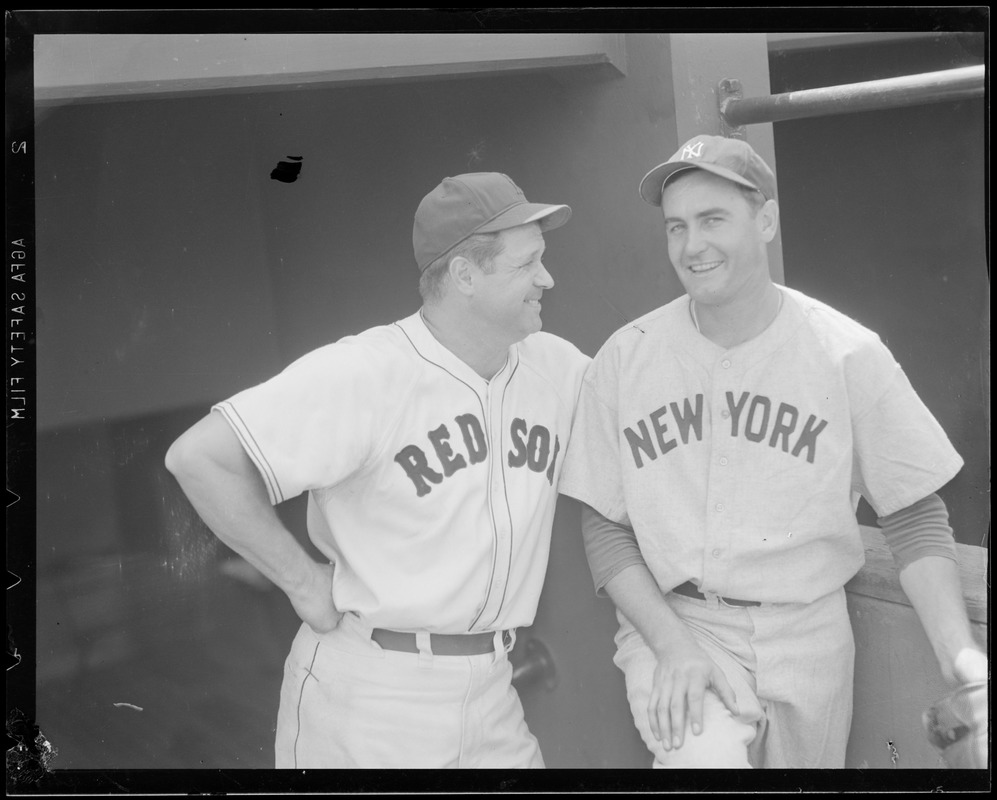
[{"x1": 848, "y1": 338, "x2": 963, "y2": 517}]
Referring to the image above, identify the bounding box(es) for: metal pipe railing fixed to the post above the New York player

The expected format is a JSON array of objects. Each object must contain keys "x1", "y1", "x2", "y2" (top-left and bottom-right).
[{"x1": 720, "y1": 64, "x2": 986, "y2": 128}]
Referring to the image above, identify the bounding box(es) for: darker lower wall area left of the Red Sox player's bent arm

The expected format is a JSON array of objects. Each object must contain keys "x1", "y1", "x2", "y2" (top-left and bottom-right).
[{"x1": 36, "y1": 410, "x2": 310, "y2": 769}]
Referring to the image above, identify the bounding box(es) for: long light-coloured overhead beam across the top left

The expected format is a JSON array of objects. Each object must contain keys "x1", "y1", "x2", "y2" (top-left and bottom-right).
[{"x1": 35, "y1": 33, "x2": 626, "y2": 104}]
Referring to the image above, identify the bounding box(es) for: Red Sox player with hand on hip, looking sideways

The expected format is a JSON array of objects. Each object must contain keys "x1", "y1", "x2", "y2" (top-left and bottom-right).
[{"x1": 167, "y1": 173, "x2": 589, "y2": 769}]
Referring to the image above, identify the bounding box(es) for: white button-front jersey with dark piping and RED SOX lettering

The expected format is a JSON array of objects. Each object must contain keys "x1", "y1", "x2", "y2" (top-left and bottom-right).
[{"x1": 215, "y1": 313, "x2": 589, "y2": 633}]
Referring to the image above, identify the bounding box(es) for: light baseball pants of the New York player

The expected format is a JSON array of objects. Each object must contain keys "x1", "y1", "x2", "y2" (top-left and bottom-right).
[{"x1": 614, "y1": 589, "x2": 855, "y2": 769}]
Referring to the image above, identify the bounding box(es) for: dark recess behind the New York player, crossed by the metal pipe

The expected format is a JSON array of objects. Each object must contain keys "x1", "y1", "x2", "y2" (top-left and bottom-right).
[{"x1": 770, "y1": 34, "x2": 990, "y2": 545}]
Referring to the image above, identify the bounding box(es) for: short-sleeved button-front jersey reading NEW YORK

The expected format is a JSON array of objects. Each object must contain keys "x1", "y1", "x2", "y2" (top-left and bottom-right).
[{"x1": 560, "y1": 287, "x2": 962, "y2": 602}]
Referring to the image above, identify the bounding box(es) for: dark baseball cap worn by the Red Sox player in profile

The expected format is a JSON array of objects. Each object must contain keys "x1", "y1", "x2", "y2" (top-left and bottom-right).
[{"x1": 412, "y1": 172, "x2": 571, "y2": 272}]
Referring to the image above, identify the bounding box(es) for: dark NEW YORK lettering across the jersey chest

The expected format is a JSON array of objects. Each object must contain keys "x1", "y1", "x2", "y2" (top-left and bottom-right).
[{"x1": 623, "y1": 392, "x2": 827, "y2": 469}]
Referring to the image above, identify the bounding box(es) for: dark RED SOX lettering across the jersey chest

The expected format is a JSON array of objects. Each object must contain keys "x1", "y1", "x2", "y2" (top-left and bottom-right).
[{"x1": 395, "y1": 414, "x2": 561, "y2": 497}]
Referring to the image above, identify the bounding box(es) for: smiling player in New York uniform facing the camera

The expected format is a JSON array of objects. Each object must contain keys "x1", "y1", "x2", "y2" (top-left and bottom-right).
[{"x1": 561, "y1": 136, "x2": 986, "y2": 768}]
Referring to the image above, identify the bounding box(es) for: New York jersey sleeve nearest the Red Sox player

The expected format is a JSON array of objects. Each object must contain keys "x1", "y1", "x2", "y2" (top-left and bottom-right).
[{"x1": 558, "y1": 339, "x2": 630, "y2": 525}]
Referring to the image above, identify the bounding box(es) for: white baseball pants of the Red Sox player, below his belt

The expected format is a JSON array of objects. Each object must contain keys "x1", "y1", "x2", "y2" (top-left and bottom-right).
[{"x1": 275, "y1": 614, "x2": 544, "y2": 769}]
